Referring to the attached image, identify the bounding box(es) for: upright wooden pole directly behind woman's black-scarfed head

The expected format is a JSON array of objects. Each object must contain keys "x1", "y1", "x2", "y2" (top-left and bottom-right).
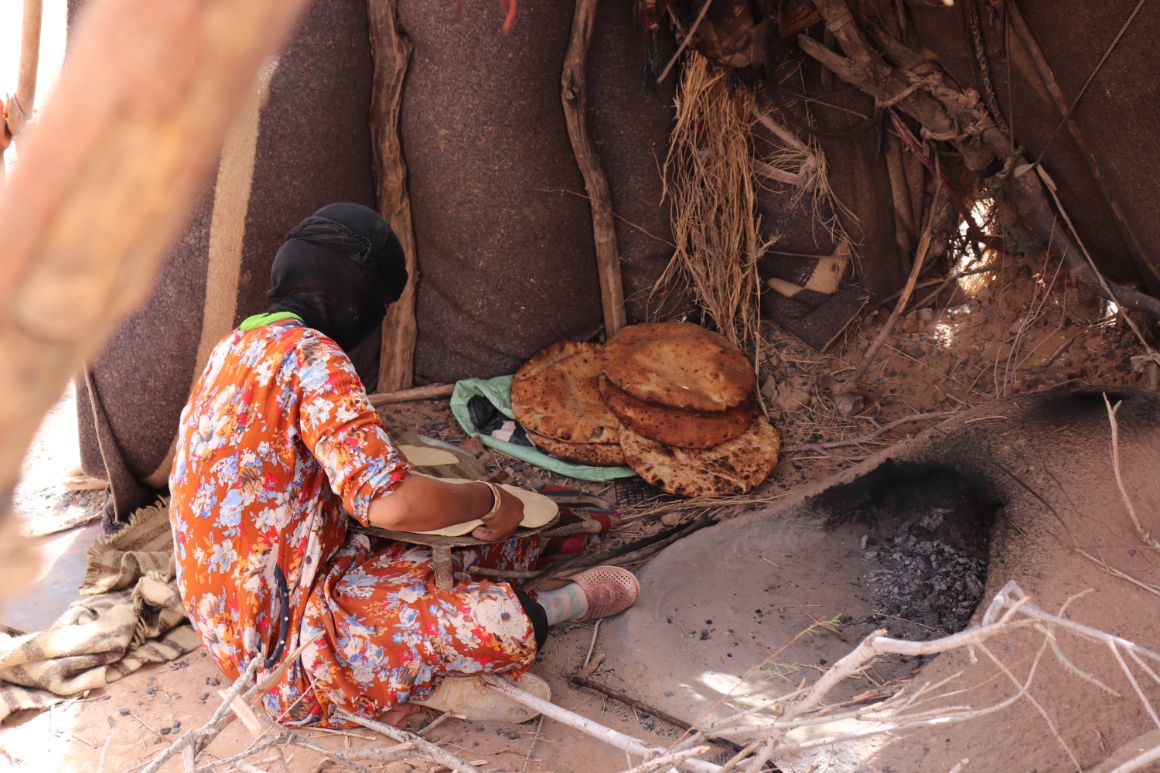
[{"x1": 367, "y1": 0, "x2": 419, "y2": 392}]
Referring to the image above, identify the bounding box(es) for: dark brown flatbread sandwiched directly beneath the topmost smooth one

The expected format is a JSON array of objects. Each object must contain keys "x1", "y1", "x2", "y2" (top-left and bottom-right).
[{"x1": 600, "y1": 376, "x2": 753, "y2": 448}]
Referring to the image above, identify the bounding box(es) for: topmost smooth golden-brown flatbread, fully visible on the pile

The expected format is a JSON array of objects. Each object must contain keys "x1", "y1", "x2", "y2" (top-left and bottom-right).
[{"x1": 604, "y1": 322, "x2": 756, "y2": 411}]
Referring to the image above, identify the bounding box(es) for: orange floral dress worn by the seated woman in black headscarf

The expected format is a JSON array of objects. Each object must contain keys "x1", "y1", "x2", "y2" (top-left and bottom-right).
[{"x1": 169, "y1": 318, "x2": 538, "y2": 727}]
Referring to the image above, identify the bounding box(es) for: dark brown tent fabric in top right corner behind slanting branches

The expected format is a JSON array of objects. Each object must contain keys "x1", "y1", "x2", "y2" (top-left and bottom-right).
[{"x1": 911, "y1": 0, "x2": 1160, "y2": 292}]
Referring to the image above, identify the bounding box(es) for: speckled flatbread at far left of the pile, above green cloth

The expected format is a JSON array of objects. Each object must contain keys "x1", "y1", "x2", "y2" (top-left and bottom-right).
[{"x1": 512, "y1": 341, "x2": 619, "y2": 445}]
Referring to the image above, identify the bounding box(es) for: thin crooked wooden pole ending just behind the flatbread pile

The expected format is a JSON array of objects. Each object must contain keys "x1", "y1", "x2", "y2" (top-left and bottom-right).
[{"x1": 560, "y1": 0, "x2": 628, "y2": 338}]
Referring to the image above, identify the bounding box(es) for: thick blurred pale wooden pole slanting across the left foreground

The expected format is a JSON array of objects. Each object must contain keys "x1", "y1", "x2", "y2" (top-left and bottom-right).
[{"x1": 0, "y1": 0, "x2": 306, "y2": 521}]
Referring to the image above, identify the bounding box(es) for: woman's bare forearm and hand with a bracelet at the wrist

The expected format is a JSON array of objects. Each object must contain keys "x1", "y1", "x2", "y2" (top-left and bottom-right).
[{"x1": 367, "y1": 475, "x2": 523, "y2": 542}]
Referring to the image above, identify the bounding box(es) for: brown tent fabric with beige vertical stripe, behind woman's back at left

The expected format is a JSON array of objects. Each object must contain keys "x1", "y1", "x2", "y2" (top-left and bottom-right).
[{"x1": 78, "y1": 0, "x2": 378, "y2": 528}]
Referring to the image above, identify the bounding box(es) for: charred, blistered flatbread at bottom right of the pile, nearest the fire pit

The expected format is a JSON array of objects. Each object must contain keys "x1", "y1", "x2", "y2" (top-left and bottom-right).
[{"x1": 621, "y1": 416, "x2": 781, "y2": 497}]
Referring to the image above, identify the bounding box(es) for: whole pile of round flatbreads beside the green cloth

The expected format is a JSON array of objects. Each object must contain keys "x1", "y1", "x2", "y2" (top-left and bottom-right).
[{"x1": 512, "y1": 322, "x2": 781, "y2": 497}]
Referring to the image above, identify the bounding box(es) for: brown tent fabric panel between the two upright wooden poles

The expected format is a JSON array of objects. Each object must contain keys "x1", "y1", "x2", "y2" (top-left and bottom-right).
[{"x1": 399, "y1": 0, "x2": 602, "y2": 381}]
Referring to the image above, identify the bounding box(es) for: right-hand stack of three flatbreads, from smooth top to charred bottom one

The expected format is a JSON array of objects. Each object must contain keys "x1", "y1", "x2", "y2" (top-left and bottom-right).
[{"x1": 600, "y1": 322, "x2": 781, "y2": 497}]
